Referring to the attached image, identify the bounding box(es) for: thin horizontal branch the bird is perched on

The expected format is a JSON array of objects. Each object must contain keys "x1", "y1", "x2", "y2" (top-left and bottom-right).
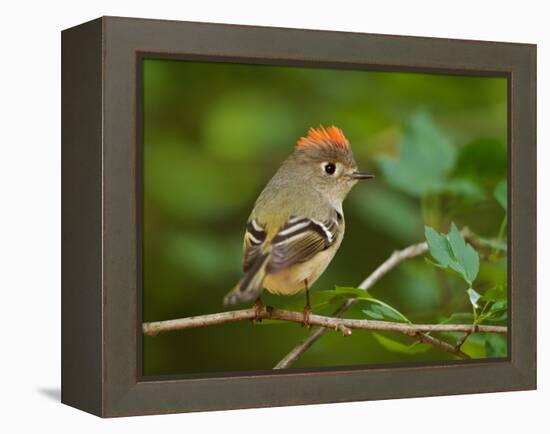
[{"x1": 143, "y1": 307, "x2": 507, "y2": 339}]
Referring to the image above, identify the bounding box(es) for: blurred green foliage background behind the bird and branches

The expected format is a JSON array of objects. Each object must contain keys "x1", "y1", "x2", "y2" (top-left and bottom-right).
[{"x1": 143, "y1": 59, "x2": 507, "y2": 375}]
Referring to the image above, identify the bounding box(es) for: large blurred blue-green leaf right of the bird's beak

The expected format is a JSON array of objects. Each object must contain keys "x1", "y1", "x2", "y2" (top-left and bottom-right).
[{"x1": 378, "y1": 111, "x2": 456, "y2": 196}]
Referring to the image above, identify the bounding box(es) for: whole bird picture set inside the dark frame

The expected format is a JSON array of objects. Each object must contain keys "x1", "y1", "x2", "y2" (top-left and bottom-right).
[{"x1": 138, "y1": 57, "x2": 509, "y2": 377}]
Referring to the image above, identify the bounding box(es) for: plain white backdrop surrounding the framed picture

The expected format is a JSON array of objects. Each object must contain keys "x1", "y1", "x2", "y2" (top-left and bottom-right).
[{"x1": 0, "y1": 0, "x2": 550, "y2": 433}]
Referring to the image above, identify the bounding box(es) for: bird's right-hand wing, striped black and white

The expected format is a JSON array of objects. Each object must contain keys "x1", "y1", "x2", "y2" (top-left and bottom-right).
[{"x1": 267, "y1": 217, "x2": 339, "y2": 272}]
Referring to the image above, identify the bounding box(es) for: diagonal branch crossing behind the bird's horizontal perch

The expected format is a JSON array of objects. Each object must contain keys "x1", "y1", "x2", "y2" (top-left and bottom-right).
[{"x1": 273, "y1": 242, "x2": 432, "y2": 369}]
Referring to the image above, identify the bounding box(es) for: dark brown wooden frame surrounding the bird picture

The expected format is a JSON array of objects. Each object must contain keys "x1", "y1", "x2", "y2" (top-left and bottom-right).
[{"x1": 62, "y1": 17, "x2": 536, "y2": 417}]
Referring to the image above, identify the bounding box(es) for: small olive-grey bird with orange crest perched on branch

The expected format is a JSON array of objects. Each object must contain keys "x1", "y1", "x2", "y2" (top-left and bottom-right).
[{"x1": 224, "y1": 126, "x2": 373, "y2": 327}]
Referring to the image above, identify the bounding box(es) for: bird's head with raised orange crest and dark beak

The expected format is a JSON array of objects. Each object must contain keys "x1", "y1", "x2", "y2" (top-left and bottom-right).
[{"x1": 291, "y1": 126, "x2": 374, "y2": 202}]
